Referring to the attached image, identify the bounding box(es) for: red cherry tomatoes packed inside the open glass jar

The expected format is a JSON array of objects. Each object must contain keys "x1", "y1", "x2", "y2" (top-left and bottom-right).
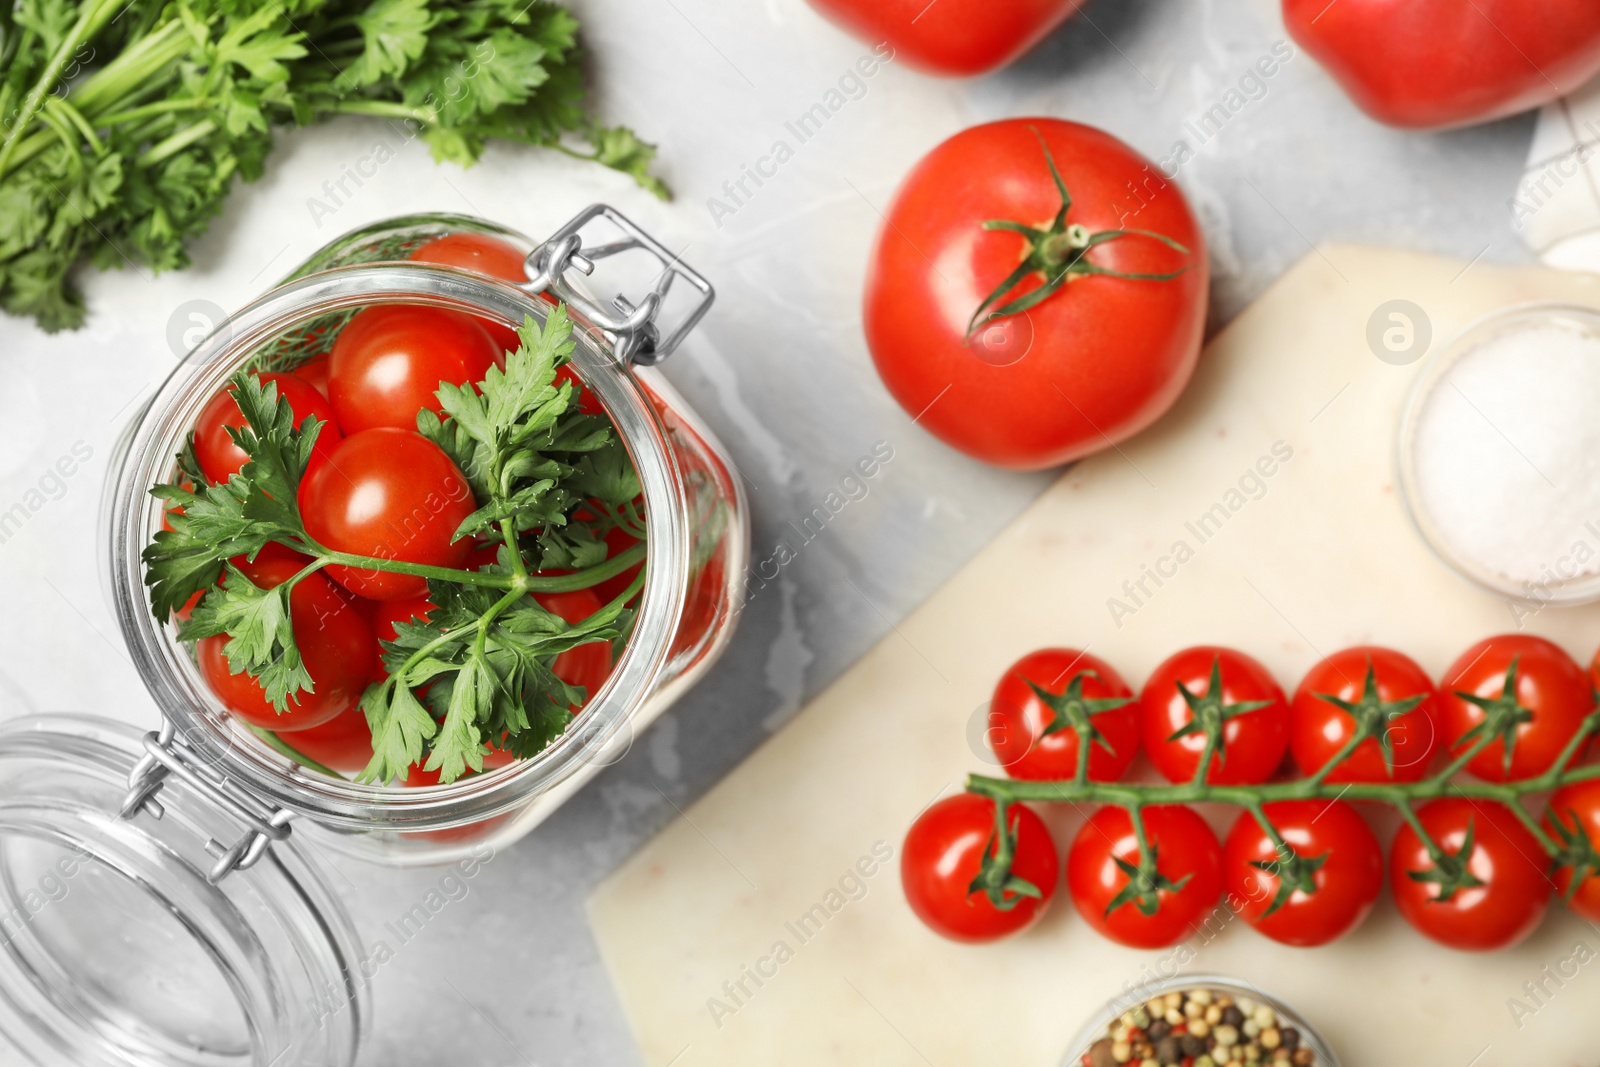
[{"x1": 179, "y1": 234, "x2": 624, "y2": 785}]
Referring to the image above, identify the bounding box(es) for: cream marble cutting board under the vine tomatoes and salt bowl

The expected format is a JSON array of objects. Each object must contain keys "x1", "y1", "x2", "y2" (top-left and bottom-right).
[{"x1": 589, "y1": 246, "x2": 1600, "y2": 1067}]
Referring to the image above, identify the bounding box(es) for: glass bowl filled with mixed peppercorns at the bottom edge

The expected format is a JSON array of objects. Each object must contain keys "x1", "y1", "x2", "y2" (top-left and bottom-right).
[{"x1": 1062, "y1": 974, "x2": 1339, "y2": 1067}]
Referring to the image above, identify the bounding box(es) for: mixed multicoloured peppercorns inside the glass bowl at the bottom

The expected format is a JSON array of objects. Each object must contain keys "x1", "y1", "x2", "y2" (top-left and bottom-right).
[{"x1": 1080, "y1": 989, "x2": 1317, "y2": 1067}]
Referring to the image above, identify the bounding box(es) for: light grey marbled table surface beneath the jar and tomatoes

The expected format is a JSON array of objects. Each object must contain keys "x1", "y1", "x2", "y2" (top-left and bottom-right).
[{"x1": 0, "y1": 0, "x2": 1531, "y2": 1067}]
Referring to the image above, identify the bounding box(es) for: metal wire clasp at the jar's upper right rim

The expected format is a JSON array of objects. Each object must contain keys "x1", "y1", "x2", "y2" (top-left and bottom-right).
[{"x1": 520, "y1": 203, "x2": 717, "y2": 366}]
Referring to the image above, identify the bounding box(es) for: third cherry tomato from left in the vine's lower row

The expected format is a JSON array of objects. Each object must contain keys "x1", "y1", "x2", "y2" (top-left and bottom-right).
[{"x1": 1222, "y1": 800, "x2": 1384, "y2": 947}]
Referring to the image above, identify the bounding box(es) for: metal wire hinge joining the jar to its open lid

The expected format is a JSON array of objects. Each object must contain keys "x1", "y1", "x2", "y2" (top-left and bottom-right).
[{"x1": 118, "y1": 720, "x2": 293, "y2": 885}]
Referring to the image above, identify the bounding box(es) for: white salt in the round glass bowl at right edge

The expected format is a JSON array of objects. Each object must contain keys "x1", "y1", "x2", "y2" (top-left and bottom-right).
[{"x1": 1413, "y1": 320, "x2": 1600, "y2": 595}]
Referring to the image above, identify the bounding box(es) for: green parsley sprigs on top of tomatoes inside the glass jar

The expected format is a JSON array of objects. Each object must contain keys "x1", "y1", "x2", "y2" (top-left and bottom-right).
[{"x1": 144, "y1": 307, "x2": 645, "y2": 782}]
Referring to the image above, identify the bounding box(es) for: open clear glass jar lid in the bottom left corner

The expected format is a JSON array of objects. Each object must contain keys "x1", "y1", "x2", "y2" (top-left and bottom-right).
[{"x1": 0, "y1": 715, "x2": 368, "y2": 1067}]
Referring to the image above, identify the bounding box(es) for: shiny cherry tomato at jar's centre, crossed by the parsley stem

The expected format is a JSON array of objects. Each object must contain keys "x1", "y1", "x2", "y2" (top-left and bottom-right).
[{"x1": 299, "y1": 429, "x2": 477, "y2": 600}]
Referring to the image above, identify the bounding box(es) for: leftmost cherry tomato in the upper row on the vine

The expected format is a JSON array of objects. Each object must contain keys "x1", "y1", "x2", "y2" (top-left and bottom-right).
[{"x1": 989, "y1": 648, "x2": 1139, "y2": 782}]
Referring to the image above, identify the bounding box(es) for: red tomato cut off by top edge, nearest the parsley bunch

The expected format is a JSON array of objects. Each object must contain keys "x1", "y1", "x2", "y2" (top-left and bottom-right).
[{"x1": 811, "y1": 0, "x2": 1083, "y2": 78}]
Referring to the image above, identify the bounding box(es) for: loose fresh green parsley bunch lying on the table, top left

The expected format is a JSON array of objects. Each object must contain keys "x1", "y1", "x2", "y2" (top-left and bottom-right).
[{"x1": 0, "y1": 0, "x2": 666, "y2": 330}]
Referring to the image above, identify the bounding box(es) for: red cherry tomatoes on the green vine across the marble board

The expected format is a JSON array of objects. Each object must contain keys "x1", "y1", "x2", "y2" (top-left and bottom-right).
[{"x1": 901, "y1": 635, "x2": 1600, "y2": 950}]
